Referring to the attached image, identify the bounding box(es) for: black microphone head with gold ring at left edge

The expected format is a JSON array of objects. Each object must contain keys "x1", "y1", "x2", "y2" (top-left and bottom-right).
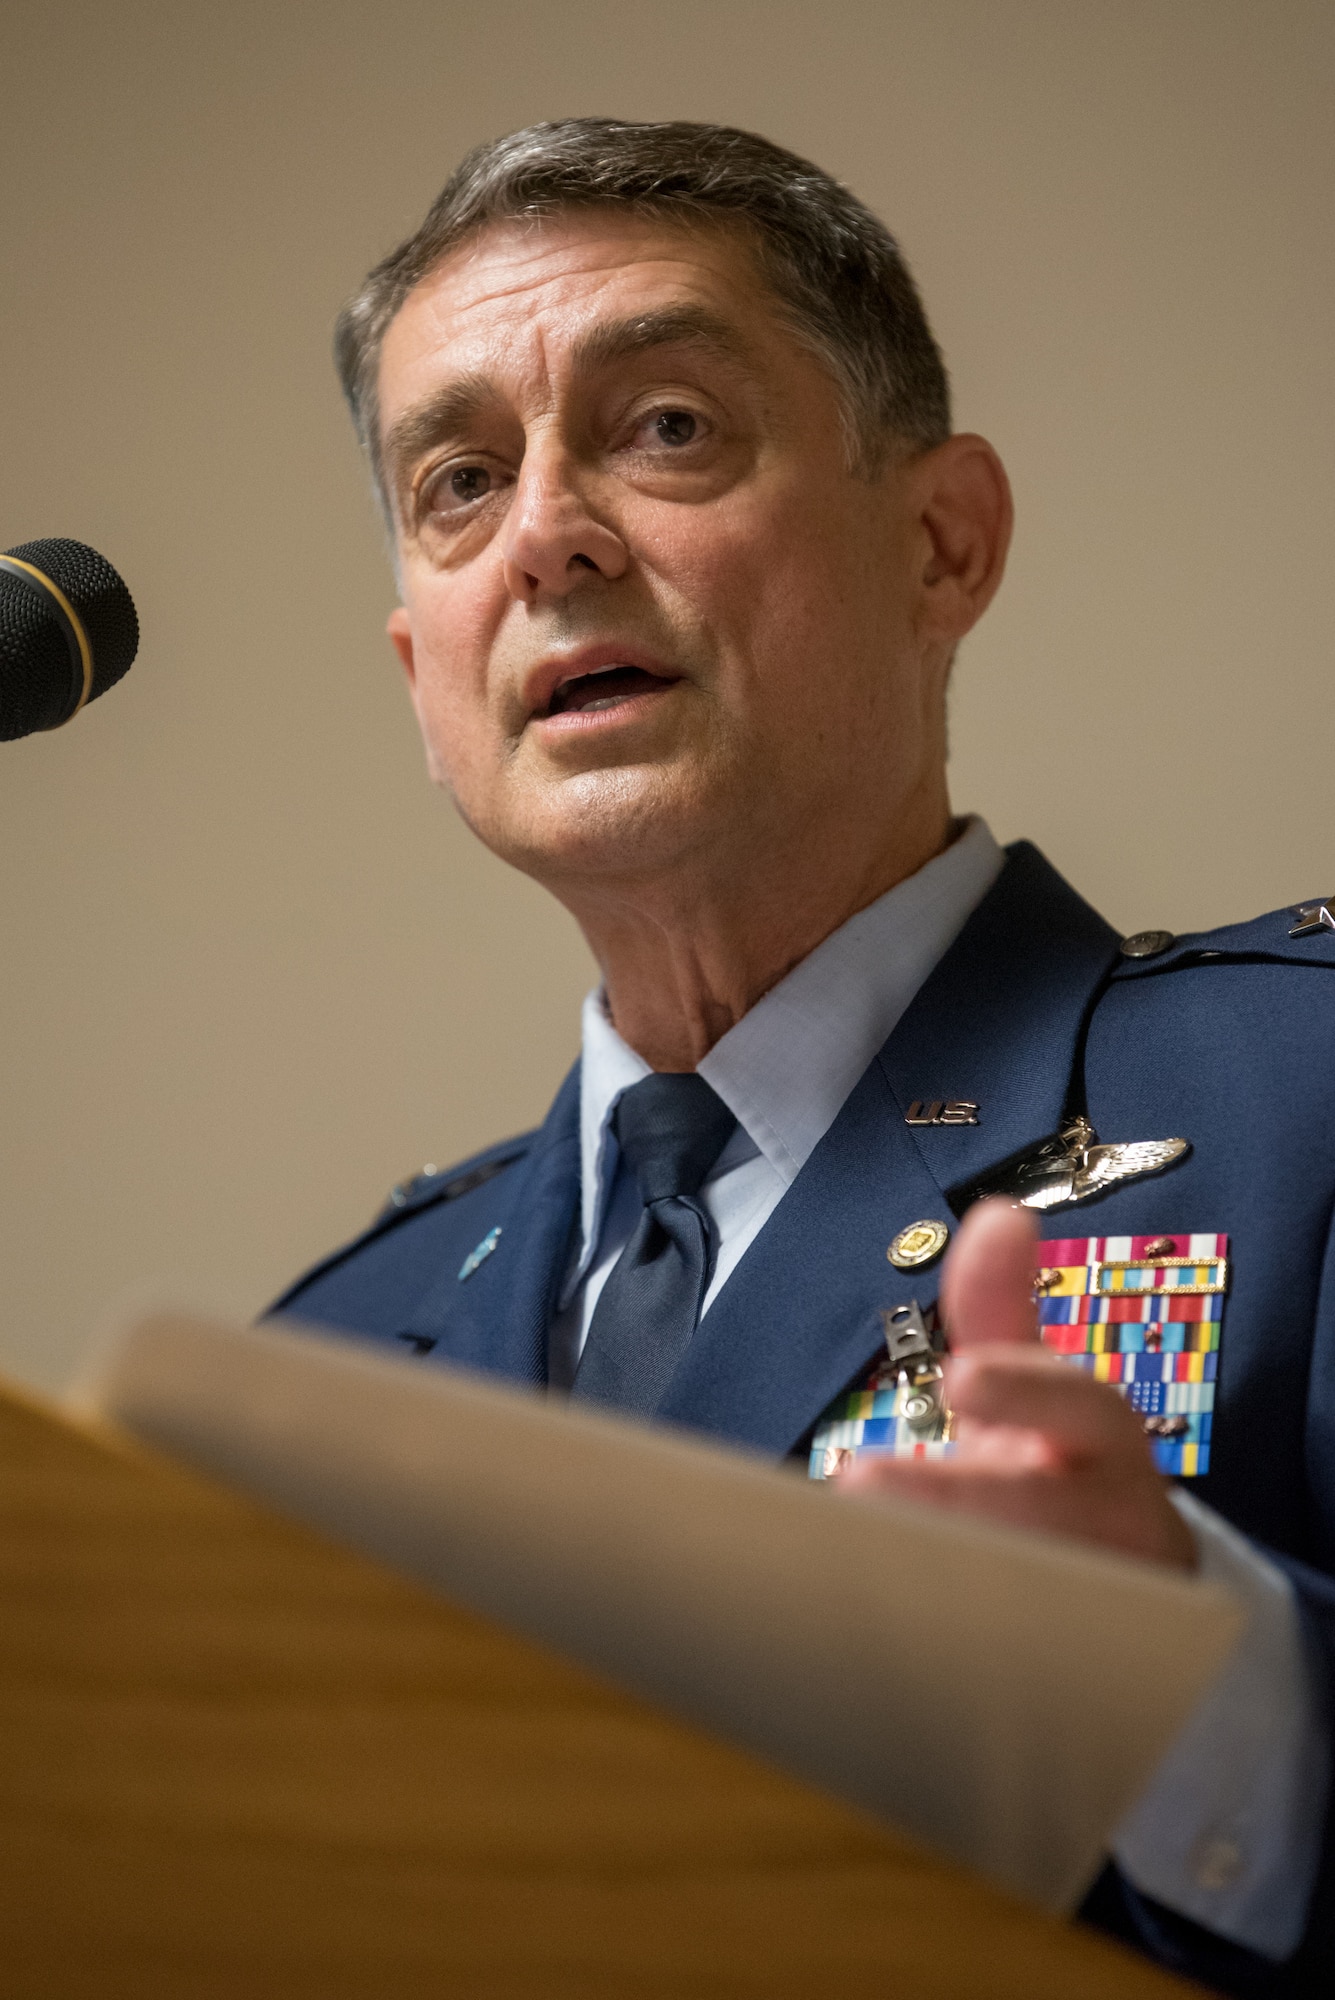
[{"x1": 0, "y1": 536, "x2": 140, "y2": 742}]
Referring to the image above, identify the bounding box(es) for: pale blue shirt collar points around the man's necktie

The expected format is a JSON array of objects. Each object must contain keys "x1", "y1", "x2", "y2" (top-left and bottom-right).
[{"x1": 572, "y1": 818, "x2": 1005, "y2": 1284}]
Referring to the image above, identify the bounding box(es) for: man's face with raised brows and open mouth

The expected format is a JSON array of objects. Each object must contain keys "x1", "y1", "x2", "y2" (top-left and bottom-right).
[{"x1": 380, "y1": 212, "x2": 945, "y2": 894}]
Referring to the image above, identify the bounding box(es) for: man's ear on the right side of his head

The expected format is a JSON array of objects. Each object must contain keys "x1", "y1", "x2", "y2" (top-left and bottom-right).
[{"x1": 909, "y1": 432, "x2": 1015, "y2": 646}]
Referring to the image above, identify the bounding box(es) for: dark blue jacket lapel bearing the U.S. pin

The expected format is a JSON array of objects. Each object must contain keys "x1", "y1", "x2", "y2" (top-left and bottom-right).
[{"x1": 660, "y1": 842, "x2": 1117, "y2": 1452}]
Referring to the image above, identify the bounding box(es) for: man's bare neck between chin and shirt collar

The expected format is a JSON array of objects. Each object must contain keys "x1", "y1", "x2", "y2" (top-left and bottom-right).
[{"x1": 564, "y1": 798, "x2": 957, "y2": 1070}]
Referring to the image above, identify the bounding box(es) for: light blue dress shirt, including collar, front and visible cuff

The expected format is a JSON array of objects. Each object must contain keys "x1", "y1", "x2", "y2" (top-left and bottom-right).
[{"x1": 550, "y1": 818, "x2": 1327, "y2": 1958}]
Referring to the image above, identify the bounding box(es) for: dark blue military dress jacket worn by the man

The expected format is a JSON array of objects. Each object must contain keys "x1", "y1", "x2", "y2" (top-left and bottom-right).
[{"x1": 274, "y1": 842, "x2": 1335, "y2": 1996}]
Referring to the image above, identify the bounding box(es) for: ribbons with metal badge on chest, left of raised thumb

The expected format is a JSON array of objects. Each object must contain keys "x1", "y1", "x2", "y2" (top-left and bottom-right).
[{"x1": 807, "y1": 1300, "x2": 953, "y2": 1480}]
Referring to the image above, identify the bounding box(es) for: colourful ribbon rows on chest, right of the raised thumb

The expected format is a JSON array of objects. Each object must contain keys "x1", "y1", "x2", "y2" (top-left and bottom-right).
[{"x1": 1035, "y1": 1232, "x2": 1229, "y2": 1478}]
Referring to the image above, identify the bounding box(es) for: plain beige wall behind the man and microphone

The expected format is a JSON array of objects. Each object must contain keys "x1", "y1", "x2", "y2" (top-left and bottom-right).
[{"x1": 0, "y1": 0, "x2": 1335, "y2": 1384}]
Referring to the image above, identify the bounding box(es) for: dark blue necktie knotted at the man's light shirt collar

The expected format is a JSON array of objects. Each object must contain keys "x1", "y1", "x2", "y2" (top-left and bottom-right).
[{"x1": 572, "y1": 1070, "x2": 737, "y2": 1416}]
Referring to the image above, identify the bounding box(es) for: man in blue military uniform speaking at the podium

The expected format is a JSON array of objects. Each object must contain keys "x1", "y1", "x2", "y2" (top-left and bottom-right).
[{"x1": 278, "y1": 120, "x2": 1335, "y2": 1994}]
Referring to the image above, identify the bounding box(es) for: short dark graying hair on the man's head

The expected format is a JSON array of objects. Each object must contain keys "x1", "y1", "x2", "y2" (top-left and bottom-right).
[{"x1": 334, "y1": 118, "x2": 951, "y2": 516}]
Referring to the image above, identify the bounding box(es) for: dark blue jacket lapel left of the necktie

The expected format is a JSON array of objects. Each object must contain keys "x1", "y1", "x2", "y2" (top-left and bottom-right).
[{"x1": 406, "y1": 1064, "x2": 580, "y2": 1382}]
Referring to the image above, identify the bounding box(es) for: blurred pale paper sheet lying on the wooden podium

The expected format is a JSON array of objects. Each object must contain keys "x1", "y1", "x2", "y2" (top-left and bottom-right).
[{"x1": 70, "y1": 1314, "x2": 1241, "y2": 1910}]
